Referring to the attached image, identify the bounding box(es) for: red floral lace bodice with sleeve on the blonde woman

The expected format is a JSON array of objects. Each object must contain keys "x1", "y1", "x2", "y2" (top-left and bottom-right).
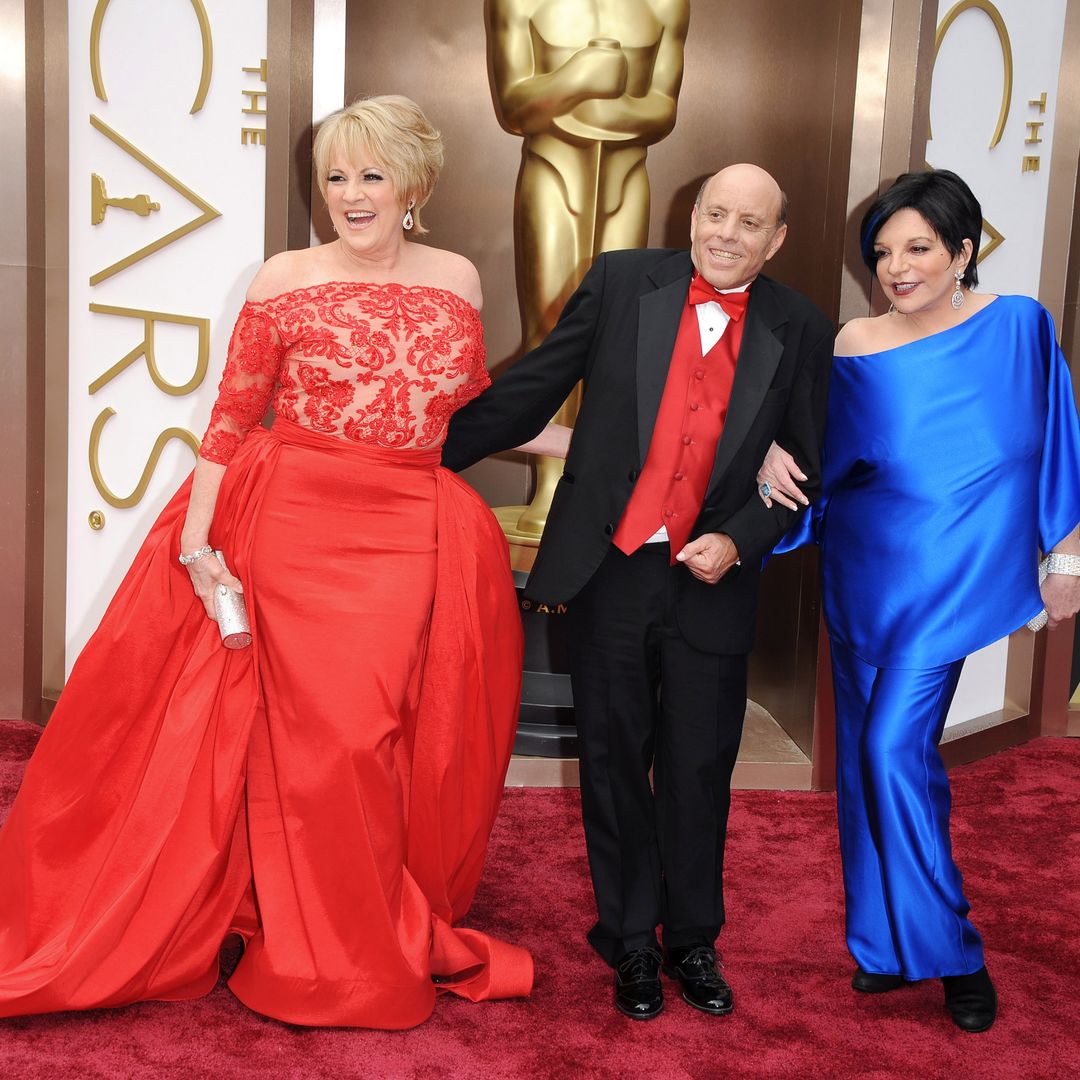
[{"x1": 200, "y1": 282, "x2": 490, "y2": 464}]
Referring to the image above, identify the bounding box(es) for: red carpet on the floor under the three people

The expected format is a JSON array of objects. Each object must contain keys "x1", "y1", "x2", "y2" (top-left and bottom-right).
[{"x1": 0, "y1": 723, "x2": 1080, "y2": 1080}]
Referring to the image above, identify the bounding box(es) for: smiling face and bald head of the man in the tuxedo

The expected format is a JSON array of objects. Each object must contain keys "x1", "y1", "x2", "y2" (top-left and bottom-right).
[{"x1": 690, "y1": 165, "x2": 787, "y2": 288}]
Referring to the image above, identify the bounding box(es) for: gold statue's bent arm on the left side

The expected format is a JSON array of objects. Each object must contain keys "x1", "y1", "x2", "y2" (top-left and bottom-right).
[{"x1": 488, "y1": 0, "x2": 626, "y2": 135}]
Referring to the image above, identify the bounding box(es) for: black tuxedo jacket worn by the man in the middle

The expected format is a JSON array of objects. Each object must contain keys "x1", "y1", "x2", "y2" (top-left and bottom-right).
[{"x1": 443, "y1": 248, "x2": 835, "y2": 652}]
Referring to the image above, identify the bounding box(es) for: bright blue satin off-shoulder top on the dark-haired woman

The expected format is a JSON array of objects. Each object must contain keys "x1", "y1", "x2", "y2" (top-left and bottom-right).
[{"x1": 777, "y1": 296, "x2": 1080, "y2": 667}]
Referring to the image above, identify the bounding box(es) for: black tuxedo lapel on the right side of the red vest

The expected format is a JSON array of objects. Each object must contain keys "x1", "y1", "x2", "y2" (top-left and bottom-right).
[{"x1": 706, "y1": 279, "x2": 787, "y2": 499}]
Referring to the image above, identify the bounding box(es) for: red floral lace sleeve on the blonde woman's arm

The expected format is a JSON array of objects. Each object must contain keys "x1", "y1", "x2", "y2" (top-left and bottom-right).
[{"x1": 199, "y1": 303, "x2": 285, "y2": 465}]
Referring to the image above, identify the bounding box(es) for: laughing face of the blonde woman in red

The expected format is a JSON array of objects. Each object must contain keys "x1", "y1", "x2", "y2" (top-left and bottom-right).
[{"x1": 326, "y1": 150, "x2": 406, "y2": 257}]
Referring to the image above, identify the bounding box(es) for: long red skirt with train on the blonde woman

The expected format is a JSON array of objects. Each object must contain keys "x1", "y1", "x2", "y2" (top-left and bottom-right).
[{"x1": 0, "y1": 421, "x2": 532, "y2": 1028}]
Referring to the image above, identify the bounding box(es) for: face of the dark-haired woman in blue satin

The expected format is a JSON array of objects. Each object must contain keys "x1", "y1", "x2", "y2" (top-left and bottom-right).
[{"x1": 874, "y1": 206, "x2": 972, "y2": 315}]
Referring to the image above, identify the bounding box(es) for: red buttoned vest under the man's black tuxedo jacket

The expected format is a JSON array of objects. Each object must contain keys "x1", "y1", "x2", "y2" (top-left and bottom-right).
[{"x1": 612, "y1": 291, "x2": 744, "y2": 563}]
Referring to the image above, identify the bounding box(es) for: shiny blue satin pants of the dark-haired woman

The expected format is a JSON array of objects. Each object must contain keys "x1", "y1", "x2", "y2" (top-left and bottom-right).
[{"x1": 831, "y1": 640, "x2": 983, "y2": 980}]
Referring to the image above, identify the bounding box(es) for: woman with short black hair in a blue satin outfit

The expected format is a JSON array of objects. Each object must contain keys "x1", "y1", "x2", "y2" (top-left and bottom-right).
[{"x1": 758, "y1": 170, "x2": 1080, "y2": 1031}]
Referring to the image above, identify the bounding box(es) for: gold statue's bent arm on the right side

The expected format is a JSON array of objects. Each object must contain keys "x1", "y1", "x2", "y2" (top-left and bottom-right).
[{"x1": 573, "y1": 0, "x2": 690, "y2": 144}]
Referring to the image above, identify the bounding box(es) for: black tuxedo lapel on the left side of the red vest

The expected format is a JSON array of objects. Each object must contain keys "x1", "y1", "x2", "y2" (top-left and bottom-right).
[{"x1": 637, "y1": 255, "x2": 693, "y2": 465}]
